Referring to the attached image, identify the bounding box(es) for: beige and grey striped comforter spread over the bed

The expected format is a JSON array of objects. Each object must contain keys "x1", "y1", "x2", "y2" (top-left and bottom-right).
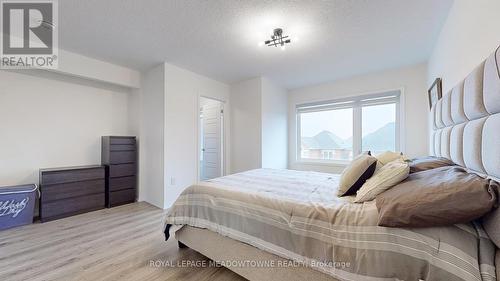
[{"x1": 165, "y1": 169, "x2": 496, "y2": 281}]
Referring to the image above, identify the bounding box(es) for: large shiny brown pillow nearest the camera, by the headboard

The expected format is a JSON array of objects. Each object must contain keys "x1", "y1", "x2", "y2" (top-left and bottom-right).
[{"x1": 376, "y1": 166, "x2": 498, "y2": 227}]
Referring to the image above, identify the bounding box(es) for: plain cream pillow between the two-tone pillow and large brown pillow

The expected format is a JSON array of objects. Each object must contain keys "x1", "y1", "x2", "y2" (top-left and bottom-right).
[{"x1": 354, "y1": 159, "x2": 410, "y2": 203}]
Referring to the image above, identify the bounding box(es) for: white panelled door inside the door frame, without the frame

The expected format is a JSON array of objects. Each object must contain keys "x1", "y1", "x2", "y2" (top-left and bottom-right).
[{"x1": 200, "y1": 98, "x2": 223, "y2": 180}]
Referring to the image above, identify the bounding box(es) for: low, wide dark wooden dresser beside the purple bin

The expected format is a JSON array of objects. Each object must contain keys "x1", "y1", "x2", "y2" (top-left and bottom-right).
[{"x1": 39, "y1": 166, "x2": 105, "y2": 222}]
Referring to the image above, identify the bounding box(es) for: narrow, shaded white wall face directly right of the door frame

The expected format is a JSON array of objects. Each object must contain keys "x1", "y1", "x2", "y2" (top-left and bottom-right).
[{"x1": 231, "y1": 78, "x2": 262, "y2": 173}]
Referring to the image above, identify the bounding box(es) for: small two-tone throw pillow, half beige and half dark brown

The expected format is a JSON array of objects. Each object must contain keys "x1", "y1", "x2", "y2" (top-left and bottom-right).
[{"x1": 338, "y1": 154, "x2": 377, "y2": 196}]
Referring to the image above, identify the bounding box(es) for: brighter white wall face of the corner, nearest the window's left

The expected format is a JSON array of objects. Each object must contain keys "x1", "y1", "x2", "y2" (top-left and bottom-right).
[{"x1": 261, "y1": 78, "x2": 288, "y2": 169}]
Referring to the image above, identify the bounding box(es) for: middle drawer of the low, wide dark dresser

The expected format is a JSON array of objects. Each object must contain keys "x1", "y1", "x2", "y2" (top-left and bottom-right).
[{"x1": 40, "y1": 179, "x2": 105, "y2": 203}]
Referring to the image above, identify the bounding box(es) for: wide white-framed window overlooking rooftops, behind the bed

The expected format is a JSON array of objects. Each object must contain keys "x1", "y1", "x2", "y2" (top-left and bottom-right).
[{"x1": 297, "y1": 91, "x2": 401, "y2": 162}]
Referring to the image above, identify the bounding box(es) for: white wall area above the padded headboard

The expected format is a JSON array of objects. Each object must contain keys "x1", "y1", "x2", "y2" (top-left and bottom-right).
[{"x1": 427, "y1": 0, "x2": 500, "y2": 93}]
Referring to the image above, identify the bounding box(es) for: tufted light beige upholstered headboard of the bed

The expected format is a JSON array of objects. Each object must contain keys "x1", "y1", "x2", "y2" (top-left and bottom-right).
[{"x1": 431, "y1": 47, "x2": 500, "y2": 180}]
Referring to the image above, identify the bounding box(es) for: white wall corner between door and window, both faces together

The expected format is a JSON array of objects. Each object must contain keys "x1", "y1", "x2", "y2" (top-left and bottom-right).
[{"x1": 231, "y1": 77, "x2": 288, "y2": 173}]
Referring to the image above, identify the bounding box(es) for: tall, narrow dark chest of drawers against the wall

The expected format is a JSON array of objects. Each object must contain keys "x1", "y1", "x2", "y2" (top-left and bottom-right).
[{"x1": 101, "y1": 136, "x2": 137, "y2": 208}]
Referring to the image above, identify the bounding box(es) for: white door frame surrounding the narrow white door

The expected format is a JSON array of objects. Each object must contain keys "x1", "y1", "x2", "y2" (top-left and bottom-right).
[{"x1": 195, "y1": 93, "x2": 229, "y2": 182}]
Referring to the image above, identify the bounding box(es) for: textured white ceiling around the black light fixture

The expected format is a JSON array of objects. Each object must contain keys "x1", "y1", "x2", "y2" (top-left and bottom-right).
[{"x1": 59, "y1": 0, "x2": 453, "y2": 88}]
